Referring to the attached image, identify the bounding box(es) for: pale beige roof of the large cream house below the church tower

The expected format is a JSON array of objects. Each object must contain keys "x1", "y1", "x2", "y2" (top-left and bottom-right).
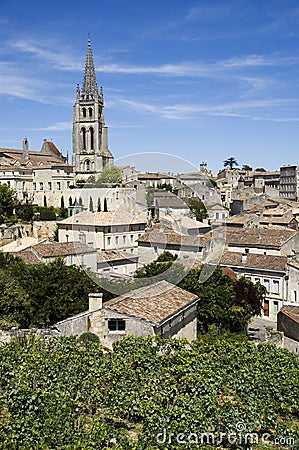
[{"x1": 59, "y1": 211, "x2": 146, "y2": 226}]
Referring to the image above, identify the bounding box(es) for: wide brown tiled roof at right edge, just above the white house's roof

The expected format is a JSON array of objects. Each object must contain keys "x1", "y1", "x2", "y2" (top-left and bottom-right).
[{"x1": 226, "y1": 227, "x2": 298, "y2": 248}]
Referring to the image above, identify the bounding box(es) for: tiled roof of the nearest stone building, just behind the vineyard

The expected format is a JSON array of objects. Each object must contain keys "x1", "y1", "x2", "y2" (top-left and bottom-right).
[{"x1": 103, "y1": 280, "x2": 198, "y2": 325}]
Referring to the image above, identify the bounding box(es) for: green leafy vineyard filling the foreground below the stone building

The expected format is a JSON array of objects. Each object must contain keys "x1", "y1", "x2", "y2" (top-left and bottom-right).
[{"x1": 0, "y1": 336, "x2": 299, "y2": 450}]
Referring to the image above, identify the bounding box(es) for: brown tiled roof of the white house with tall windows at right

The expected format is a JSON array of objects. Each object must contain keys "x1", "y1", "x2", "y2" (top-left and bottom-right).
[{"x1": 220, "y1": 252, "x2": 287, "y2": 271}]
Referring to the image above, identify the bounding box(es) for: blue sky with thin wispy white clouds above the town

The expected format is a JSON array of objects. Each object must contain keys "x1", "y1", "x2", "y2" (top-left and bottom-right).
[{"x1": 0, "y1": 0, "x2": 299, "y2": 172}]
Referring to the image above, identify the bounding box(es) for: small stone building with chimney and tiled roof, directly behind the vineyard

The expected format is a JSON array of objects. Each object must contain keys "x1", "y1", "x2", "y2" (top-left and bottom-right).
[{"x1": 55, "y1": 281, "x2": 199, "y2": 348}]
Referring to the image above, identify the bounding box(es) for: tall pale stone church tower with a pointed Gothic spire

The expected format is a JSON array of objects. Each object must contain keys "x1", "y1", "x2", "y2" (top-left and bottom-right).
[{"x1": 73, "y1": 39, "x2": 114, "y2": 184}]
